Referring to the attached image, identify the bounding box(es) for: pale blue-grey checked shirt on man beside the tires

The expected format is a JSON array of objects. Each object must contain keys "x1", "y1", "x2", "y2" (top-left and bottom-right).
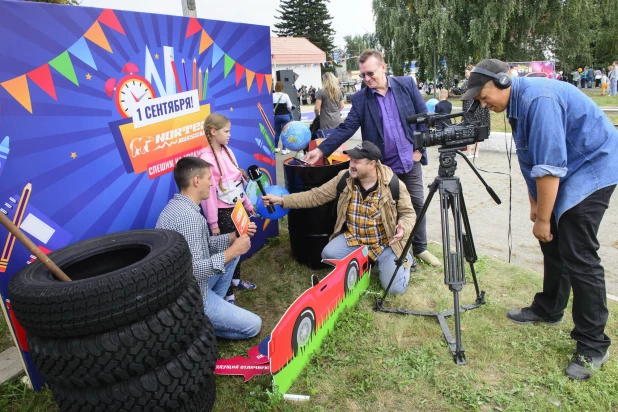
[{"x1": 156, "y1": 193, "x2": 230, "y2": 298}]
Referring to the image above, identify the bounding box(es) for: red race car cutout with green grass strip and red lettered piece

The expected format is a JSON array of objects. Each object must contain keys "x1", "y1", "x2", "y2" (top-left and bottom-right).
[{"x1": 215, "y1": 247, "x2": 370, "y2": 395}]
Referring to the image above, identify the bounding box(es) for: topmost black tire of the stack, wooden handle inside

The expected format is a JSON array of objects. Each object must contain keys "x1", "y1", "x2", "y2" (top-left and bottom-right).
[{"x1": 9, "y1": 230, "x2": 193, "y2": 338}]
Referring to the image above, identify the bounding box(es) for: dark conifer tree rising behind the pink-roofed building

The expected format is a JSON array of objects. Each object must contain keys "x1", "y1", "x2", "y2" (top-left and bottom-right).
[{"x1": 274, "y1": 0, "x2": 335, "y2": 56}]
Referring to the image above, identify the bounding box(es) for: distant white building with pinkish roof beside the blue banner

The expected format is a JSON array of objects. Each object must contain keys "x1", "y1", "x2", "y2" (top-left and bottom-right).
[{"x1": 271, "y1": 37, "x2": 326, "y2": 90}]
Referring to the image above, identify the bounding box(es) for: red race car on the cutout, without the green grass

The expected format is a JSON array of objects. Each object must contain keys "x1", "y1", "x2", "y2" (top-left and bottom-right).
[{"x1": 268, "y1": 247, "x2": 369, "y2": 374}]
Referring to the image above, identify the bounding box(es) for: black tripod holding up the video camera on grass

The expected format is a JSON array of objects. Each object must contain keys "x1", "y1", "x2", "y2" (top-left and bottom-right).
[{"x1": 375, "y1": 148, "x2": 501, "y2": 365}]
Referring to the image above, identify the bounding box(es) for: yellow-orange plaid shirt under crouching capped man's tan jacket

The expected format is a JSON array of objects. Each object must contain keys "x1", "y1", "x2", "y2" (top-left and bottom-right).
[{"x1": 343, "y1": 185, "x2": 388, "y2": 261}]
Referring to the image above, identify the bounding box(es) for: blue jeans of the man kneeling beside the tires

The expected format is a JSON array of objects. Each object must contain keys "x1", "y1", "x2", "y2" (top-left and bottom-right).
[{"x1": 202, "y1": 257, "x2": 262, "y2": 339}]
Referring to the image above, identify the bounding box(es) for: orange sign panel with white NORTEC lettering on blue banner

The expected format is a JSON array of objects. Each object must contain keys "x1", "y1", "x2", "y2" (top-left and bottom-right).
[{"x1": 118, "y1": 104, "x2": 210, "y2": 174}]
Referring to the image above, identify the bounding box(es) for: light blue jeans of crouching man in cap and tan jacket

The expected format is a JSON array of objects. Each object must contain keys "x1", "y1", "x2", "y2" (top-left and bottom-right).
[{"x1": 322, "y1": 234, "x2": 412, "y2": 295}]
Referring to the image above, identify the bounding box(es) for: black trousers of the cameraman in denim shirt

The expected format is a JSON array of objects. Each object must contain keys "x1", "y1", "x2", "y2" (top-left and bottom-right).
[{"x1": 531, "y1": 185, "x2": 616, "y2": 356}]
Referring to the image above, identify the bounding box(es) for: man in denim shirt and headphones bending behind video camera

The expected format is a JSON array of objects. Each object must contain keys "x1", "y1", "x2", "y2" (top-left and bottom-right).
[{"x1": 462, "y1": 59, "x2": 618, "y2": 380}]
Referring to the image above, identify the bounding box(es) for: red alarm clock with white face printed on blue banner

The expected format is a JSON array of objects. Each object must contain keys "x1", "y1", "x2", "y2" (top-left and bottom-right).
[{"x1": 105, "y1": 63, "x2": 157, "y2": 118}]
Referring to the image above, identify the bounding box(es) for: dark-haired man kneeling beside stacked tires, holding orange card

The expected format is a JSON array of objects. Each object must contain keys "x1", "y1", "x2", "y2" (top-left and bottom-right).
[{"x1": 156, "y1": 157, "x2": 262, "y2": 339}]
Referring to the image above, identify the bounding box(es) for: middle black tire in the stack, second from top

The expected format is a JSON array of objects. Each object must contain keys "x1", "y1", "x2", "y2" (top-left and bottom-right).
[{"x1": 29, "y1": 280, "x2": 205, "y2": 388}]
